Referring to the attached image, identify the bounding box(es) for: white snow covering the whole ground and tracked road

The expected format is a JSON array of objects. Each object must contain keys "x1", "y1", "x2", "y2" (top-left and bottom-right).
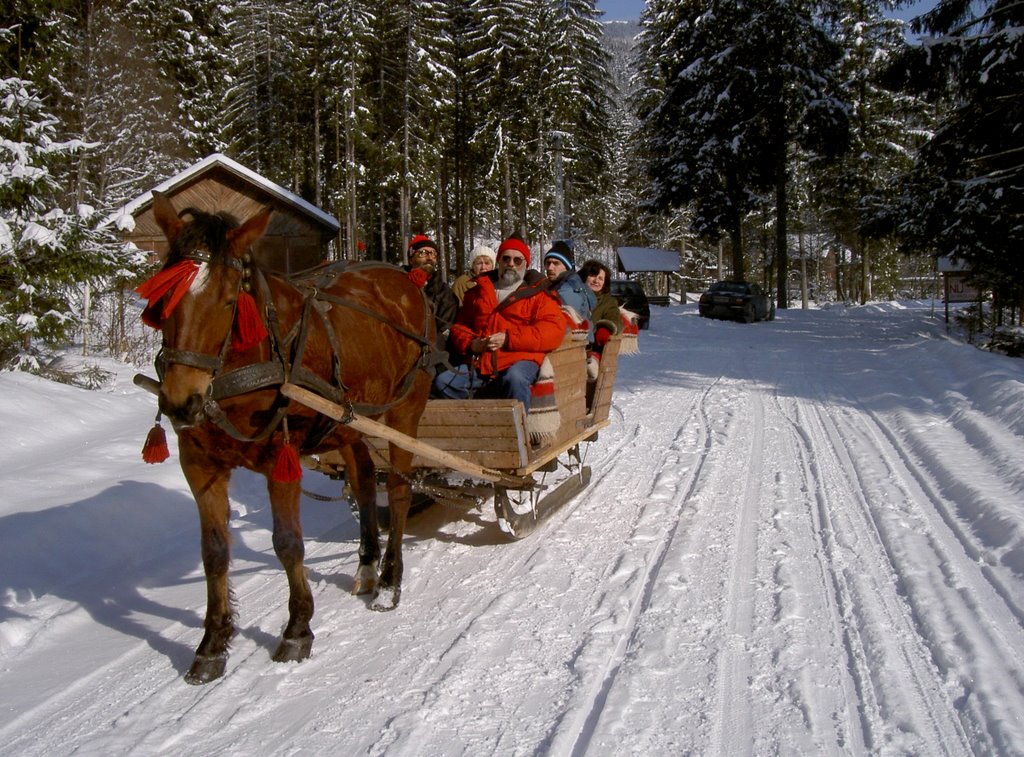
[{"x1": 0, "y1": 302, "x2": 1024, "y2": 755}]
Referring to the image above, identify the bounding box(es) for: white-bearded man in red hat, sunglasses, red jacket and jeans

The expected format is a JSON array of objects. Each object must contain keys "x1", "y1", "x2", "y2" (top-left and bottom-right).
[{"x1": 434, "y1": 237, "x2": 566, "y2": 410}]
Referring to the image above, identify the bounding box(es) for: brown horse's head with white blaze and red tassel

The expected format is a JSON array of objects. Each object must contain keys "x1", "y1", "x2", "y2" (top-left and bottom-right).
[{"x1": 139, "y1": 192, "x2": 271, "y2": 429}]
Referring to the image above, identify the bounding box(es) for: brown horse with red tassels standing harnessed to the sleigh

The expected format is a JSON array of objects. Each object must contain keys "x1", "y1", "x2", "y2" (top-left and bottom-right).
[{"x1": 140, "y1": 193, "x2": 434, "y2": 683}]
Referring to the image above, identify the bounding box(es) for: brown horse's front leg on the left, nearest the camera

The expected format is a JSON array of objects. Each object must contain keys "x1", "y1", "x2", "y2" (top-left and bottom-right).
[{"x1": 179, "y1": 450, "x2": 234, "y2": 683}]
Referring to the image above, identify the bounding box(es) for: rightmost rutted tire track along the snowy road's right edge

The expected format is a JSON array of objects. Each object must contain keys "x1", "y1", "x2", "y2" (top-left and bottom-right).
[{"x1": 843, "y1": 408, "x2": 1024, "y2": 752}]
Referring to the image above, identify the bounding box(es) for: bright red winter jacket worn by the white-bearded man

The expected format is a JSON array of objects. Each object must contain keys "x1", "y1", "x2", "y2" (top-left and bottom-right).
[{"x1": 450, "y1": 271, "x2": 566, "y2": 376}]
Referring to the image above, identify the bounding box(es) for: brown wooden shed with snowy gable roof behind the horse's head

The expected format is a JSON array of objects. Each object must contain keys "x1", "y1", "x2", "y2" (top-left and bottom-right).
[{"x1": 109, "y1": 153, "x2": 340, "y2": 274}]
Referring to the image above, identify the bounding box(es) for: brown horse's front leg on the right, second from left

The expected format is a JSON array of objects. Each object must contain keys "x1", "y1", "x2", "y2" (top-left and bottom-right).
[{"x1": 267, "y1": 476, "x2": 313, "y2": 663}]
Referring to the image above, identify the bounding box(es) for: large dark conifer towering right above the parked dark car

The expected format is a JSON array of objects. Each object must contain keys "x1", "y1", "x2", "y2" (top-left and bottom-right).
[{"x1": 644, "y1": 0, "x2": 847, "y2": 297}]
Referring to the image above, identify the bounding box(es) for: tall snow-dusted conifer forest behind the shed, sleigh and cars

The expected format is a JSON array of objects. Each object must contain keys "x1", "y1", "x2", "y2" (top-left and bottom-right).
[{"x1": 0, "y1": 0, "x2": 1024, "y2": 368}]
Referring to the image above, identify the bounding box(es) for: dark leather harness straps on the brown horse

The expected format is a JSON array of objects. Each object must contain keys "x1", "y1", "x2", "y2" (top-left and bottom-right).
[{"x1": 156, "y1": 255, "x2": 444, "y2": 441}]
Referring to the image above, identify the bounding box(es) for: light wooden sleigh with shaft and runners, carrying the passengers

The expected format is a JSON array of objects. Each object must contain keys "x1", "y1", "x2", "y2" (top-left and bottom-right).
[{"x1": 290, "y1": 336, "x2": 621, "y2": 539}]
